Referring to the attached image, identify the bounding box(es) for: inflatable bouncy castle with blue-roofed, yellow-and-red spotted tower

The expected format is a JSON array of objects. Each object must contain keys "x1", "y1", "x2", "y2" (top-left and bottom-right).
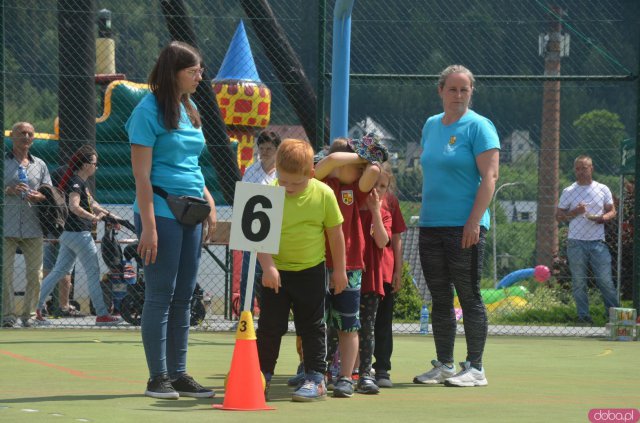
[{"x1": 4, "y1": 22, "x2": 271, "y2": 206}]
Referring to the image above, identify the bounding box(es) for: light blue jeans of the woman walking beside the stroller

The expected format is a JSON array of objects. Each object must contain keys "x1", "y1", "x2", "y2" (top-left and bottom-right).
[{"x1": 37, "y1": 231, "x2": 109, "y2": 316}]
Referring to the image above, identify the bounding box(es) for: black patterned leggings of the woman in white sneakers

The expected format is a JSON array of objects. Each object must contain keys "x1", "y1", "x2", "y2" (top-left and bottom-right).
[{"x1": 419, "y1": 227, "x2": 488, "y2": 368}]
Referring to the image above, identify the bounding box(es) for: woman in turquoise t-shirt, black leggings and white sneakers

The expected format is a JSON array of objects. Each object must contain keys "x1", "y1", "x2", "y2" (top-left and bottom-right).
[{"x1": 413, "y1": 65, "x2": 500, "y2": 386}]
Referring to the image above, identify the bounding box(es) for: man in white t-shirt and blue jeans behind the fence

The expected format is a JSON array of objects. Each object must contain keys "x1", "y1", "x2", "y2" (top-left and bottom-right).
[{"x1": 556, "y1": 156, "x2": 618, "y2": 325}]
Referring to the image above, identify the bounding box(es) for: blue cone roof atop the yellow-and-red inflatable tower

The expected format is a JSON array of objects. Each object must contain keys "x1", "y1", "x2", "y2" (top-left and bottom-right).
[{"x1": 214, "y1": 21, "x2": 261, "y2": 82}]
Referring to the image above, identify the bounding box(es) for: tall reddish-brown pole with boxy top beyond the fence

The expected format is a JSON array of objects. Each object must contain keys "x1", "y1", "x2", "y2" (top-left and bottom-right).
[{"x1": 536, "y1": 6, "x2": 569, "y2": 267}]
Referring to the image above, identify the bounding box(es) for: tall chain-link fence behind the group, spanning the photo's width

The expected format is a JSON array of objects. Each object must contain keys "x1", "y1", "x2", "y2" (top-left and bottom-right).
[{"x1": 3, "y1": 0, "x2": 640, "y2": 335}]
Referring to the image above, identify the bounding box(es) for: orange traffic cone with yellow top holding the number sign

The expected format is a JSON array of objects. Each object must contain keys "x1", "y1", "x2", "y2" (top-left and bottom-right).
[{"x1": 213, "y1": 311, "x2": 274, "y2": 411}]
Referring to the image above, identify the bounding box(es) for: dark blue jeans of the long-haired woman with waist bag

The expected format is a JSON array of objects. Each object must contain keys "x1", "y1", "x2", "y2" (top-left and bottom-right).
[{"x1": 134, "y1": 213, "x2": 202, "y2": 378}]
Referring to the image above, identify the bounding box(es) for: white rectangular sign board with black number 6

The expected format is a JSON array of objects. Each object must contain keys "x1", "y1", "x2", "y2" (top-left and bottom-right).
[{"x1": 229, "y1": 182, "x2": 284, "y2": 254}]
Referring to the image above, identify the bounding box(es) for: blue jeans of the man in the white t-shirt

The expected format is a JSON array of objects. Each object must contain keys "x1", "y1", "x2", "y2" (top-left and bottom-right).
[{"x1": 567, "y1": 239, "x2": 618, "y2": 320}]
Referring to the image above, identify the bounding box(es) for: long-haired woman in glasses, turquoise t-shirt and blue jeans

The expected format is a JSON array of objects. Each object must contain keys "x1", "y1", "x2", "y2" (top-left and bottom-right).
[{"x1": 125, "y1": 41, "x2": 216, "y2": 399}]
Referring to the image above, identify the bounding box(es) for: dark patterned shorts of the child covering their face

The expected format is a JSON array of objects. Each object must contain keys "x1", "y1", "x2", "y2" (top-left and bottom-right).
[{"x1": 324, "y1": 270, "x2": 362, "y2": 332}]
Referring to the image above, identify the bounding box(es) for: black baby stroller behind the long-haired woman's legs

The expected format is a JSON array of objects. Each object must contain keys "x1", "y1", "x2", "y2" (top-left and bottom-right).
[{"x1": 102, "y1": 216, "x2": 206, "y2": 326}]
